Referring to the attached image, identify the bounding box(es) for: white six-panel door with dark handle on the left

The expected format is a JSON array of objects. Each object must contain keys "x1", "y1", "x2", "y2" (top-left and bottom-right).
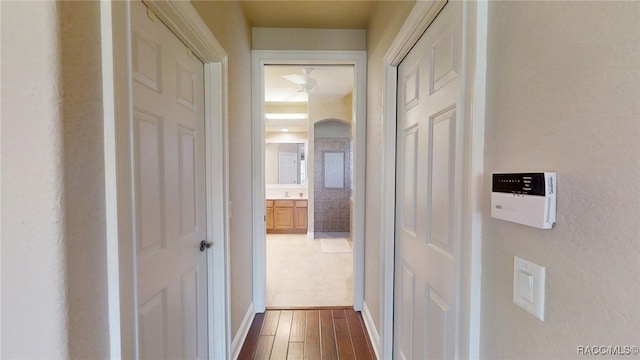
[{"x1": 131, "y1": 1, "x2": 208, "y2": 359}]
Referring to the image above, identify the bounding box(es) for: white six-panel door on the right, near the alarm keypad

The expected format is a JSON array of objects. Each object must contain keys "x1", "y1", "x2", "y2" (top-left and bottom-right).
[{"x1": 394, "y1": 2, "x2": 462, "y2": 359}]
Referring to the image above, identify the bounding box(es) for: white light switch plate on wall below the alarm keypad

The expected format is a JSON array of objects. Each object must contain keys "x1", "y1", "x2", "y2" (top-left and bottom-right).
[{"x1": 513, "y1": 256, "x2": 545, "y2": 321}]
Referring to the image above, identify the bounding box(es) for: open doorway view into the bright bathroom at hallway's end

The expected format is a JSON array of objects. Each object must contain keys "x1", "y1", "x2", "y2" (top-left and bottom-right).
[{"x1": 263, "y1": 64, "x2": 355, "y2": 308}]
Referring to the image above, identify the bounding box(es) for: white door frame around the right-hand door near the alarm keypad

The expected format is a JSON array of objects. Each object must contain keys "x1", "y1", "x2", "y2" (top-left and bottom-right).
[{"x1": 378, "y1": 0, "x2": 488, "y2": 359}]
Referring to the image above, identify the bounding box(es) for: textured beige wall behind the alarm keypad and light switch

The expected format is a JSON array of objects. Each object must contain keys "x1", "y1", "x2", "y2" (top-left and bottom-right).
[{"x1": 481, "y1": 2, "x2": 640, "y2": 359}]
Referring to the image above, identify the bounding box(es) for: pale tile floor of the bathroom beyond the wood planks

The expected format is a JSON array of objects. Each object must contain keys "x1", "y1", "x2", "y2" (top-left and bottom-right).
[{"x1": 267, "y1": 233, "x2": 353, "y2": 308}]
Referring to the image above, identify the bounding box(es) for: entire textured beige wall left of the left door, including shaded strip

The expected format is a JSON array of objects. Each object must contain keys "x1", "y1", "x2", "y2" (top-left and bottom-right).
[{"x1": 0, "y1": 2, "x2": 109, "y2": 359}]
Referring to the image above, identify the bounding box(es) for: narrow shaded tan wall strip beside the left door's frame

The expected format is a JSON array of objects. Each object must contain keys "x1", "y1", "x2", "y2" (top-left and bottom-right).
[{"x1": 58, "y1": 1, "x2": 109, "y2": 359}]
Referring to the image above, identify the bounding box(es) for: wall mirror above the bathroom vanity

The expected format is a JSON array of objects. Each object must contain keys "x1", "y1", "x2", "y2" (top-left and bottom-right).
[{"x1": 264, "y1": 142, "x2": 307, "y2": 185}]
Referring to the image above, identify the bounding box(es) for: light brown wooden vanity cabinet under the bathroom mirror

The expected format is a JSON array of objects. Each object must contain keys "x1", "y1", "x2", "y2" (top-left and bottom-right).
[{"x1": 266, "y1": 200, "x2": 307, "y2": 234}]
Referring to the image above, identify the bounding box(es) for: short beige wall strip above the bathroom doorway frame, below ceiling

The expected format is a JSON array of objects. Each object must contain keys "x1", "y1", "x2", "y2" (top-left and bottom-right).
[{"x1": 252, "y1": 28, "x2": 367, "y2": 50}]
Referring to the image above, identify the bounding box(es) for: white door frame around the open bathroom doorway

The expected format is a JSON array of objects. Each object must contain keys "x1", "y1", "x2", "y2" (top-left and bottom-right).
[{"x1": 251, "y1": 50, "x2": 367, "y2": 313}]
